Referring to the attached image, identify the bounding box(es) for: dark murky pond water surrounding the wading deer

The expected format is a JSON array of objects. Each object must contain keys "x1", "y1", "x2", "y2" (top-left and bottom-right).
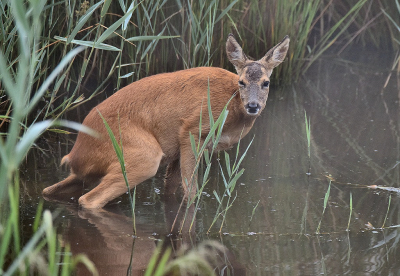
[{"x1": 22, "y1": 52, "x2": 400, "y2": 275}]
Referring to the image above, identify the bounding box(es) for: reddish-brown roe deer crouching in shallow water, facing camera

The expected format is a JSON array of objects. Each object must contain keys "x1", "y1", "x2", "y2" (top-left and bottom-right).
[{"x1": 43, "y1": 34, "x2": 289, "y2": 208}]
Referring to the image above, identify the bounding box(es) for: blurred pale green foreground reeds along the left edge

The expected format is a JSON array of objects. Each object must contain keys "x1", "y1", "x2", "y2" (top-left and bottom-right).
[{"x1": 0, "y1": 0, "x2": 164, "y2": 275}]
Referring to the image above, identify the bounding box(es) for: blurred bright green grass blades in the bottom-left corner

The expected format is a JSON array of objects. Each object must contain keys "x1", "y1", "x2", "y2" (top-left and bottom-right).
[{"x1": 0, "y1": 182, "x2": 98, "y2": 276}]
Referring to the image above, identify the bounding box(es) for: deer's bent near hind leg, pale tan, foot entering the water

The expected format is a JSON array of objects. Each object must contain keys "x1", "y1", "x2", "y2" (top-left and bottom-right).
[{"x1": 79, "y1": 133, "x2": 163, "y2": 209}]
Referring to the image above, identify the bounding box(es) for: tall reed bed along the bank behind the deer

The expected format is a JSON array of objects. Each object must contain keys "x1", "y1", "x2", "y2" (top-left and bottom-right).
[{"x1": 0, "y1": 0, "x2": 400, "y2": 123}]
